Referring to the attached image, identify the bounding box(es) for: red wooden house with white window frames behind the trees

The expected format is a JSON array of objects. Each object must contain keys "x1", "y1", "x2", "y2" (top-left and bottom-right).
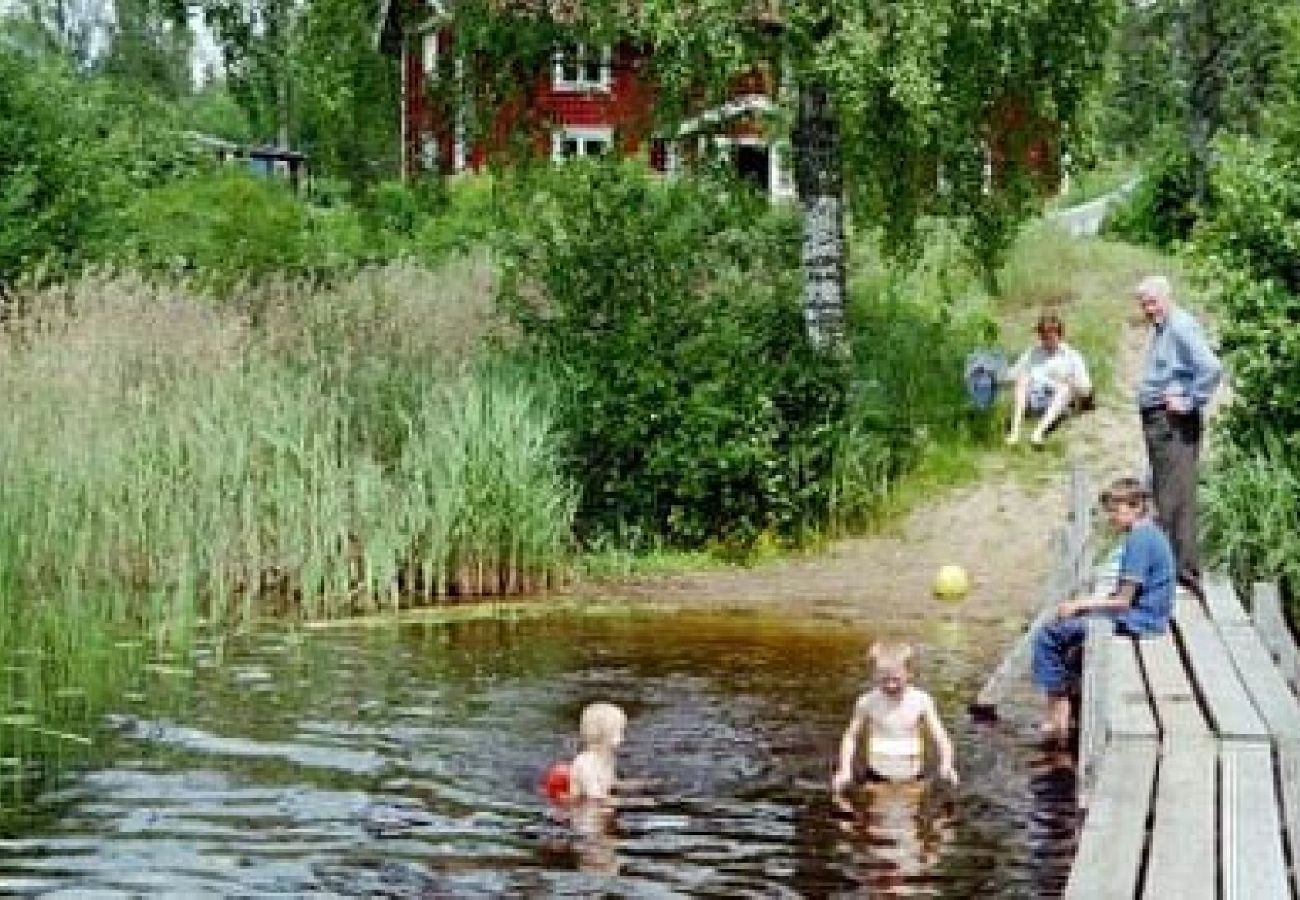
[{"x1": 378, "y1": 0, "x2": 794, "y2": 196}]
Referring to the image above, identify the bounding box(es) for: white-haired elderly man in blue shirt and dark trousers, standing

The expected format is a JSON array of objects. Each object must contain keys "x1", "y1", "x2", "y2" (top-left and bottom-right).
[{"x1": 1138, "y1": 276, "x2": 1223, "y2": 596}]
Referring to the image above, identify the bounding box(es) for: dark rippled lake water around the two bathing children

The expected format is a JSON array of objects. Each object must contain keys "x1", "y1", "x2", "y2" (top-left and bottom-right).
[{"x1": 0, "y1": 614, "x2": 1075, "y2": 899}]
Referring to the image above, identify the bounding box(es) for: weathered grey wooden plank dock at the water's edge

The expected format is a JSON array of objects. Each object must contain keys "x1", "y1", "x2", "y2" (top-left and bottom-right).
[{"x1": 1065, "y1": 577, "x2": 1300, "y2": 900}]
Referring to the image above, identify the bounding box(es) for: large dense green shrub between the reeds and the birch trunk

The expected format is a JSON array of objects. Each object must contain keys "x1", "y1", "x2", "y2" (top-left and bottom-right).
[{"x1": 491, "y1": 164, "x2": 845, "y2": 545}]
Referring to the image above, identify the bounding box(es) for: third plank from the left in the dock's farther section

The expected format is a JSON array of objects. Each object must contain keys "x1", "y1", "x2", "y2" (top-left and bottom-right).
[{"x1": 1174, "y1": 602, "x2": 1269, "y2": 744}]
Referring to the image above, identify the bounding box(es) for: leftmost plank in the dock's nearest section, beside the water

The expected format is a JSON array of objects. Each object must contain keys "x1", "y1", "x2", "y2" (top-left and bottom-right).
[{"x1": 1065, "y1": 743, "x2": 1160, "y2": 900}]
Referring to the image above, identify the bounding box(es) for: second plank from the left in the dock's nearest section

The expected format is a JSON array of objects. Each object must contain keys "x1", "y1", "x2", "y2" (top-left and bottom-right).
[{"x1": 1141, "y1": 735, "x2": 1218, "y2": 900}]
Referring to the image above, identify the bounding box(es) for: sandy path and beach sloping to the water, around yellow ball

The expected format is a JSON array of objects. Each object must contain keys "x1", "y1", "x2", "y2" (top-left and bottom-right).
[{"x1": 584, "y1": 260, "x2": 1144, "y2": 628}]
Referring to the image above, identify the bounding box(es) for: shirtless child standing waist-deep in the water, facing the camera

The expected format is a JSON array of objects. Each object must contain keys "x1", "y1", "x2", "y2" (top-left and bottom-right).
[{"x1": 831, "y1": 644, "x2": 957, "y2": 793}]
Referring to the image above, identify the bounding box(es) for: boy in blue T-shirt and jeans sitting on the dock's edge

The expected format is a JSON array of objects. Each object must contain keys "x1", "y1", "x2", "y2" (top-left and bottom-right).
[{"x1": 1034, "y1": 479, "x2": 1174, "y2": 740}]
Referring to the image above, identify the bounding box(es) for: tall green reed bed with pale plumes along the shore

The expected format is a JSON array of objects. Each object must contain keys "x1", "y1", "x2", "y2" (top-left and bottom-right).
[{"x1": 0, "y1": 260, "x2": 573, "y2": 631}]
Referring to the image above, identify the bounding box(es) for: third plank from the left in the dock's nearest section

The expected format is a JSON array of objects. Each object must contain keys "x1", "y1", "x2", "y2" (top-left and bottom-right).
[{"x1": 1219, "y1": 744, "x2": 1291, "y2": 900}]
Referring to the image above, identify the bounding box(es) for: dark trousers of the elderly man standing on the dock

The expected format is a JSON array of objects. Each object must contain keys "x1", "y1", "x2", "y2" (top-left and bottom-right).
[{"x1": 1141, "y1": 410, "x2": 1201, "y2": 596}]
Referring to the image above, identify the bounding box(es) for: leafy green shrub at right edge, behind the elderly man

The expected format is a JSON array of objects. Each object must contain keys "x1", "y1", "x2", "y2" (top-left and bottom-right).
[{"x1": 1192, "y1": 116, "x2": 1300, "y2": 596}]
